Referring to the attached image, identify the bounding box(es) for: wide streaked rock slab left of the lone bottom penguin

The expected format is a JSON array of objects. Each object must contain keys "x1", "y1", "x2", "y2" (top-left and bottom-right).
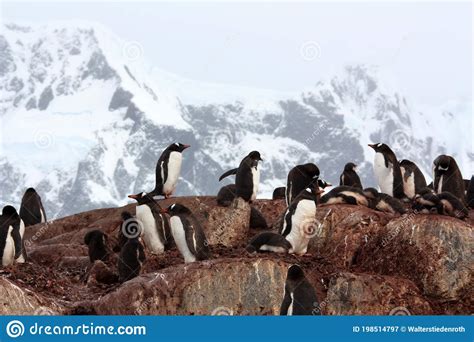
[{"x1": 90, "y1": 259, "x2": 288, "y2": 315}]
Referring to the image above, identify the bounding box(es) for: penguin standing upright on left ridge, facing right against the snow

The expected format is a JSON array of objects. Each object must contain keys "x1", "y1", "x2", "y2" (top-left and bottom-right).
[{"x1": 150, "y1": 143, "x2": 191, "y2": 198}]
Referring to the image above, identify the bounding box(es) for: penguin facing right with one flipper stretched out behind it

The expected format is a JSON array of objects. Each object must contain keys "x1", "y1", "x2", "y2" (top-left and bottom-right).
[{"x1": 219, "y1": 151, "x2": 262, "y2": 202}]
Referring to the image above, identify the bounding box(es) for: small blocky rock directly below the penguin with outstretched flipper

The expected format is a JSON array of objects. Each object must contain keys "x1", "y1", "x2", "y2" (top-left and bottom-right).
[{"x1": 205, "y1": 198, "x2": 250, "y2": 247}]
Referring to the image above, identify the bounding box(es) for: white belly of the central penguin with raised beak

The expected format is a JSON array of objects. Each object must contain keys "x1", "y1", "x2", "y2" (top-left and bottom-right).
[{"x1": 286, "y1": 200, "x2": 316, "y2": 254}]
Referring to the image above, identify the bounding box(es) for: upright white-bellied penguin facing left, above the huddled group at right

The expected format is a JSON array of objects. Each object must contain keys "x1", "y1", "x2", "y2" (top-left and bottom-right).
[{"x1": 369, "y1": 143, "x2": 406, "y2": 199}]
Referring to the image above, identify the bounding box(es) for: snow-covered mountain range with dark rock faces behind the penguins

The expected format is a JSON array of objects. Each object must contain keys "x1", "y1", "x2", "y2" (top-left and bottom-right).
[{"x1": 0, "y1": 23, "x2": 474, "y2": 217}]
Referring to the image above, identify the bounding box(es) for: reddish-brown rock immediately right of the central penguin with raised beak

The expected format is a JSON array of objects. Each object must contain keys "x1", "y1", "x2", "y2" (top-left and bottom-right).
[{"x1": 308, "y1": 204, "x2": 391, "y2": 268}]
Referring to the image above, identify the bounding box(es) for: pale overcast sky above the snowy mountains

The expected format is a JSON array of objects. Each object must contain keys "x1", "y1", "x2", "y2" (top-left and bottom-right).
[{"x1": 2, "y1": 1, "x2": 472, "y2": 106}]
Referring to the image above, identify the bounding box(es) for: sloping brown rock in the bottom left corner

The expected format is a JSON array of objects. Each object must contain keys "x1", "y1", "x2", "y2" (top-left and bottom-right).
[{"x1": 0, "y1": 278, "x2": 63, "y2": 315}]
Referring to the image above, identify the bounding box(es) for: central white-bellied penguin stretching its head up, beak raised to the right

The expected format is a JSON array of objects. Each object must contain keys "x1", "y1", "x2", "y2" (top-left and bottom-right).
[{"x1": 279, "y1": 186, "x2": 321, "y2": 255}]
